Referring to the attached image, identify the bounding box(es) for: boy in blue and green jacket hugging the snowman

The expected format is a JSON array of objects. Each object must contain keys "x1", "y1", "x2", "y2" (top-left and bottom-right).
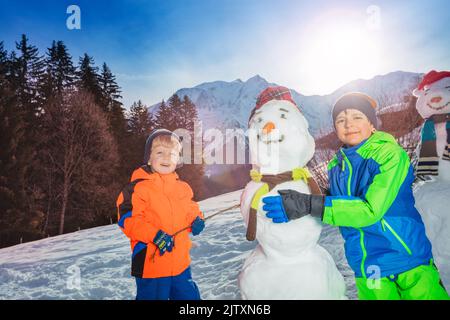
[{"x1": 263, "y1": 93, "x2": 449, "y2": 300}]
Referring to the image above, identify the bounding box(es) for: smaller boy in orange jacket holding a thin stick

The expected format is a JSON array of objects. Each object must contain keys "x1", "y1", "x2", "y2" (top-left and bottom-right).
[{"x1": 117, "y1": 129, "x2": 205, "y2": 300}]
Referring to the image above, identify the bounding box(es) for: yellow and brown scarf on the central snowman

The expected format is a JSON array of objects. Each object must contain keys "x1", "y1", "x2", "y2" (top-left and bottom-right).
[{"x1": 246, "y1": 168, "x2": 322, "y2": 241}]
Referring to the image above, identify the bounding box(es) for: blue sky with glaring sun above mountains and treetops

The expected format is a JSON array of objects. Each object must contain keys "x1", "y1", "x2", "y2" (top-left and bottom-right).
[{"x1": 0, "y1": 0, "x2": 450, "y2": 107}]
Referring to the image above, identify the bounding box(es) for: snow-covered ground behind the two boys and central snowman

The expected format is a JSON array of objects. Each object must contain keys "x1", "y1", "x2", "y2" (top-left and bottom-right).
[{"x1": 0, "y1": 191, "x2": 356, "y2": 299}]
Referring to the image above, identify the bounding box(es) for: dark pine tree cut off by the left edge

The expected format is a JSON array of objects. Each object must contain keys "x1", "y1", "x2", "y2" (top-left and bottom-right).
[{"x1": 0, "y1": 51, "x2": 43, "y2": 247}]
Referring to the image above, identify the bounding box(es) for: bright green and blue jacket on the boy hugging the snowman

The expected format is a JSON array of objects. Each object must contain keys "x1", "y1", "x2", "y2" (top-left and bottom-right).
[{"x1": 323, "y1": 131, "x2": 432, "y2": 279}]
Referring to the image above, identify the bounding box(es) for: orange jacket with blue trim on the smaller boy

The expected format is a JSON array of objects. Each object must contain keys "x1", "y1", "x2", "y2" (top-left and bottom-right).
[{"x1": 116, "y1": 166, "x2": 203, "y2": 278}]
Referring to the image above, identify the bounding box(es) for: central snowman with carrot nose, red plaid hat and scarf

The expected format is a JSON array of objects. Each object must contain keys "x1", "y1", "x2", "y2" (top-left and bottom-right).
[{"x1": 238, "y1": 87, "x2": 346, "y2": 300}]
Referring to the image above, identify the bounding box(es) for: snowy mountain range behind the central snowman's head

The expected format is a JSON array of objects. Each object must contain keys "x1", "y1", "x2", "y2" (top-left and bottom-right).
[{"x1": 149, "y1": 71, "x2": 422, "y2": 136}]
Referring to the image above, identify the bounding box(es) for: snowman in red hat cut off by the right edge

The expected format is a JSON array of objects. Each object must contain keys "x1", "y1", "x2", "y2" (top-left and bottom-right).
[{"x1": 413, "y1": 70, "x2": 450, "y2": 288}]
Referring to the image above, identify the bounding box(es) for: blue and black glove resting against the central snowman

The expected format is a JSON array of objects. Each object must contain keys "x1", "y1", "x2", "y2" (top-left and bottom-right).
[{"x1": 263, "y1": 190, "x2": 325, "y2": 223}]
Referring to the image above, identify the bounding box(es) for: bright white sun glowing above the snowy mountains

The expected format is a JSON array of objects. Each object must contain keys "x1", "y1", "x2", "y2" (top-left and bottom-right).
[{"x1": 301, "y1": 25, "x2": 380, "y2": 93}]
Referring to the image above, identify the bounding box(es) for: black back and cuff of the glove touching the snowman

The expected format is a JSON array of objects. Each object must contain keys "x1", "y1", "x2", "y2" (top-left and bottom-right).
[{"x1": 278, "y1": 190, "x2": 325, "y2": 220}]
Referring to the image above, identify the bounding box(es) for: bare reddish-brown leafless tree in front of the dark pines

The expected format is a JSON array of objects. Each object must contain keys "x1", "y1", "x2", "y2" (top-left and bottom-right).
[{"x1": 42, "y1": 91, "x2": 119, "y2": 234}]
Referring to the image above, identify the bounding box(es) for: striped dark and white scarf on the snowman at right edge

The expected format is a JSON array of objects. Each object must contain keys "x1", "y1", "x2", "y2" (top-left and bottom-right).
[{"x1": 416, "y1": 113, "x2": 450, "y2": 176}]
